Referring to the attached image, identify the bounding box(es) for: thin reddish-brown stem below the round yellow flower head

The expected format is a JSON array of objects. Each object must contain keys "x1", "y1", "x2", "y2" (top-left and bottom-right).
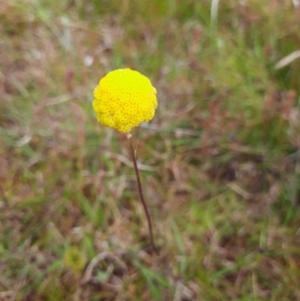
[{"x1": 127, "y1": 134, "x2": 158, "y2": 254}]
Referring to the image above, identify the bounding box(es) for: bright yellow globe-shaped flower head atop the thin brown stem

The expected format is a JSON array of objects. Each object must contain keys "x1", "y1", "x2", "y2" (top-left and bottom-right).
[{"x1": 93, "y1": 68, "x2": 157, "y2": 133}]
